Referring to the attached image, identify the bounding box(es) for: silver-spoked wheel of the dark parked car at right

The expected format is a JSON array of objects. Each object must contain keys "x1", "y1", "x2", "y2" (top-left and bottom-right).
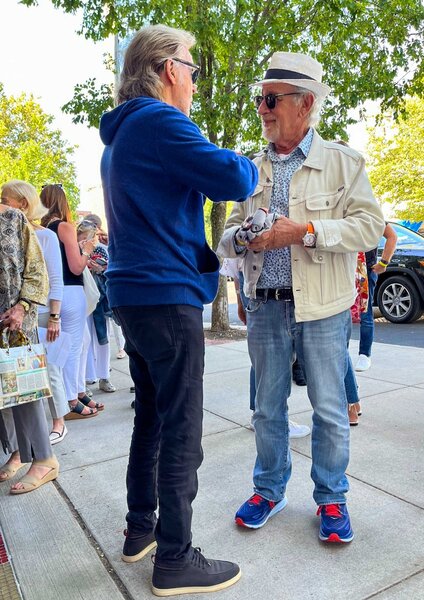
[{"x1": 377, "y1": 275, "x2": 422, "y2": 323}]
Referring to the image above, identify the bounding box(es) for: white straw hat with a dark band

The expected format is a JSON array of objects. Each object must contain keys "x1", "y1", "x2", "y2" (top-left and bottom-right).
[{"x1": 252, "y1": 52, "x2": 330, "y2": 97}]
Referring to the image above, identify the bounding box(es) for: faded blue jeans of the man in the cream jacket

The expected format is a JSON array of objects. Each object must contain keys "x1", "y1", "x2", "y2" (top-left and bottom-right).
[{"x1": 247, "y1": 300, "x2": 351, "y2": 504}]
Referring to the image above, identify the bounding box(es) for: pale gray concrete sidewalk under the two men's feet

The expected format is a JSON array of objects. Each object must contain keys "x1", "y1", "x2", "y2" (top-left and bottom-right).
[{"x1": 0, "y1": 341, "x2": 424, "y2": 600}]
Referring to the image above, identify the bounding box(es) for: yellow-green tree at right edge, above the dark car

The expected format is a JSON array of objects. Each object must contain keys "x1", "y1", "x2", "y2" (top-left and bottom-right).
[{"x1": 367, "y1": 97, "x2": 424, "y2": 221}]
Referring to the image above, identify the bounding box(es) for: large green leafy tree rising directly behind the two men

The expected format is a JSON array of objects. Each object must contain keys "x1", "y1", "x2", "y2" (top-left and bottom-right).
[{"x1": 21, "y1": 0, "x2": 424, "y2": 328}]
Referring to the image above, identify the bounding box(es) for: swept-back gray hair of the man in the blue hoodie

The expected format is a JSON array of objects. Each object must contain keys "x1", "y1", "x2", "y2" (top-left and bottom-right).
[{"x1": 117, "y1": 25, "x2": 196, "y2": 104}]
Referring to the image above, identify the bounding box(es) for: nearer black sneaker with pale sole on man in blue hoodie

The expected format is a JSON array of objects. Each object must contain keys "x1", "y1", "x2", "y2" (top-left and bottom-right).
[{"x1": 152, "y1": 548, "x2": 241, "y2": 596}]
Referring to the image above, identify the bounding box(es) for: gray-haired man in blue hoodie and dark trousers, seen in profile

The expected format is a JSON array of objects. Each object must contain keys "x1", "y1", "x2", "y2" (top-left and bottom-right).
[{"x1": 100, "y1": 25, "x2": 257, "y2": 596}]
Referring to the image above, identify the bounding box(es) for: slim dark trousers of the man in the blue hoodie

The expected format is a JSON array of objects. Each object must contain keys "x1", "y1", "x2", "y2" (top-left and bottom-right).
[{"x1": 114, "y1": 305, "x2": 205, "y2": 568}]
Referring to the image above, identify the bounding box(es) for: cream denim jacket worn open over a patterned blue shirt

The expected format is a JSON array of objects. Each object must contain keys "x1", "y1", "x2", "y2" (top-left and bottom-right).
[{"x1": 217, "y1": 131, "x2": 384, "y2": 322}]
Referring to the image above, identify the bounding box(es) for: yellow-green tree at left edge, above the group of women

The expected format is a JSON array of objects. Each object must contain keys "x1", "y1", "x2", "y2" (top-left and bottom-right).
[{"x1": 0, "y1": 84, "x2": 79, "y2": 211}]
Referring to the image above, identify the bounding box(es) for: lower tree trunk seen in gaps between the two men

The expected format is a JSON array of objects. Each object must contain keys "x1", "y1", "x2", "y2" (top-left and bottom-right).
[{"x1": 211, "y1": 202, "x2": 230, "y2": 331}]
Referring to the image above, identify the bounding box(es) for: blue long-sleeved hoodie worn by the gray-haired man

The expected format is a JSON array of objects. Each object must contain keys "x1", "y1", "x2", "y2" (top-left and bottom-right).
[{"x1": 100, "y1": 97, "x2": 258, "y2": 308}]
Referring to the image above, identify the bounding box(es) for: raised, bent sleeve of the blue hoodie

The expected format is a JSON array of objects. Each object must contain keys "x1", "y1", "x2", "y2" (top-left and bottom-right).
[{"x1": 155, "y1": 107, "x2": 258, "y2": 202}]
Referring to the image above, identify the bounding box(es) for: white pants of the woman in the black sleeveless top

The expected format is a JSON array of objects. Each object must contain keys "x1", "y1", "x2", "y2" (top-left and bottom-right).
[{"x1": 61, "y1": 285, "x2": 87, "y2": 402}]
